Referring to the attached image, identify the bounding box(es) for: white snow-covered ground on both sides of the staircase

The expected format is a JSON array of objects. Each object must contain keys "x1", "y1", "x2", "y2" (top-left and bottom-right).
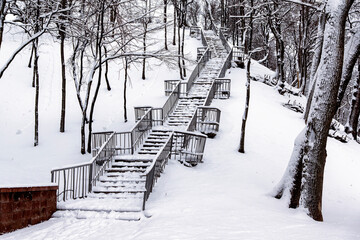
[{"x1": 0, "y1": 24, "x2": 360, "y2": 240}]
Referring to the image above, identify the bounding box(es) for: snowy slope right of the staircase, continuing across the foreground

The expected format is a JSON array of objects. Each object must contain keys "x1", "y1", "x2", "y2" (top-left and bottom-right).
[{"x1": 0, "y1": 50, "x2": 360, "y2": 240}]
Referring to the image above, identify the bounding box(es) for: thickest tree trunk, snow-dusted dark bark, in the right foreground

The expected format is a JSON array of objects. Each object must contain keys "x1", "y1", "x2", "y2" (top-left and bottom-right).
[{"x1": 274, "y1": 0, "x2": 353, "y2": 221}]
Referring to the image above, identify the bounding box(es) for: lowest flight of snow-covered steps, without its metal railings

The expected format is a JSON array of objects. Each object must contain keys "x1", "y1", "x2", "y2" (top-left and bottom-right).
[{"x1": 53, "y1": 129, "x2": 173, "y2": 221}]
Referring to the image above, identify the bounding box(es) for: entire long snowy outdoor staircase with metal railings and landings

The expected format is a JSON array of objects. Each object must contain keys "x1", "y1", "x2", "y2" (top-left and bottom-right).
[{"x1": 52, "y1": 28, "x2": 233, "y2": 220}]
